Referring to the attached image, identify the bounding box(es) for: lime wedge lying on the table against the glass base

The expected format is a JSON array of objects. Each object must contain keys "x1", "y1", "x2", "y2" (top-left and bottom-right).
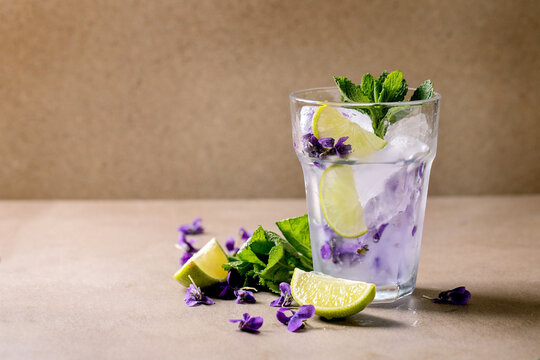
[{"x1": 291, "y1": 268, "x2": 376, "y2": 319}]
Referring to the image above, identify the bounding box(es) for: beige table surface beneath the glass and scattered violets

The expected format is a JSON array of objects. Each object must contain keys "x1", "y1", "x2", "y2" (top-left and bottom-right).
[{"x1": 0, "y1": 196, "x2": 540, "y2": 360}]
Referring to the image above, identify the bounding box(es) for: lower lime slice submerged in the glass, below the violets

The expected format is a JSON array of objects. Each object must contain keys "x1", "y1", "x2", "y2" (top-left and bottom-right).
[{"x1": 319, "y1": 165, "x2": 368, "y2": 238}]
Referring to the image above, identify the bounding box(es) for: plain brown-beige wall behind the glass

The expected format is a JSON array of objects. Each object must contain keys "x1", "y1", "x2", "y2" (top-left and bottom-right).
[{"x1": 0, "y1": 0, "x2": 540, "y2": 198}]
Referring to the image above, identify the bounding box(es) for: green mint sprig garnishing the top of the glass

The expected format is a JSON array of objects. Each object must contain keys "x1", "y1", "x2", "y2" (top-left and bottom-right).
[{"x1": 334, "y1": 70, "x2": 433, "y2": 139}]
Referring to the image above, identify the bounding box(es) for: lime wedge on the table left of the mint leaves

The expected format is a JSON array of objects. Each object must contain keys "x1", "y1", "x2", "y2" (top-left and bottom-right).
[{"x1": 174, "y1": 238, "x2": 228, "y2": 287}]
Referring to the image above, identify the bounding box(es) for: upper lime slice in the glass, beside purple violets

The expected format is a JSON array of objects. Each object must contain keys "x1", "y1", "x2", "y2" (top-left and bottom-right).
[{"x1": 313, "y1": 105, "x2": 388, "y2": 157}]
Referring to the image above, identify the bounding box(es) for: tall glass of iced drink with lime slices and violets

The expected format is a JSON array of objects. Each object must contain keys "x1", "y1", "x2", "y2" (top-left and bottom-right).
[{"x1": 290, "y1": 73, "x2": 440, "y2": 301}]
